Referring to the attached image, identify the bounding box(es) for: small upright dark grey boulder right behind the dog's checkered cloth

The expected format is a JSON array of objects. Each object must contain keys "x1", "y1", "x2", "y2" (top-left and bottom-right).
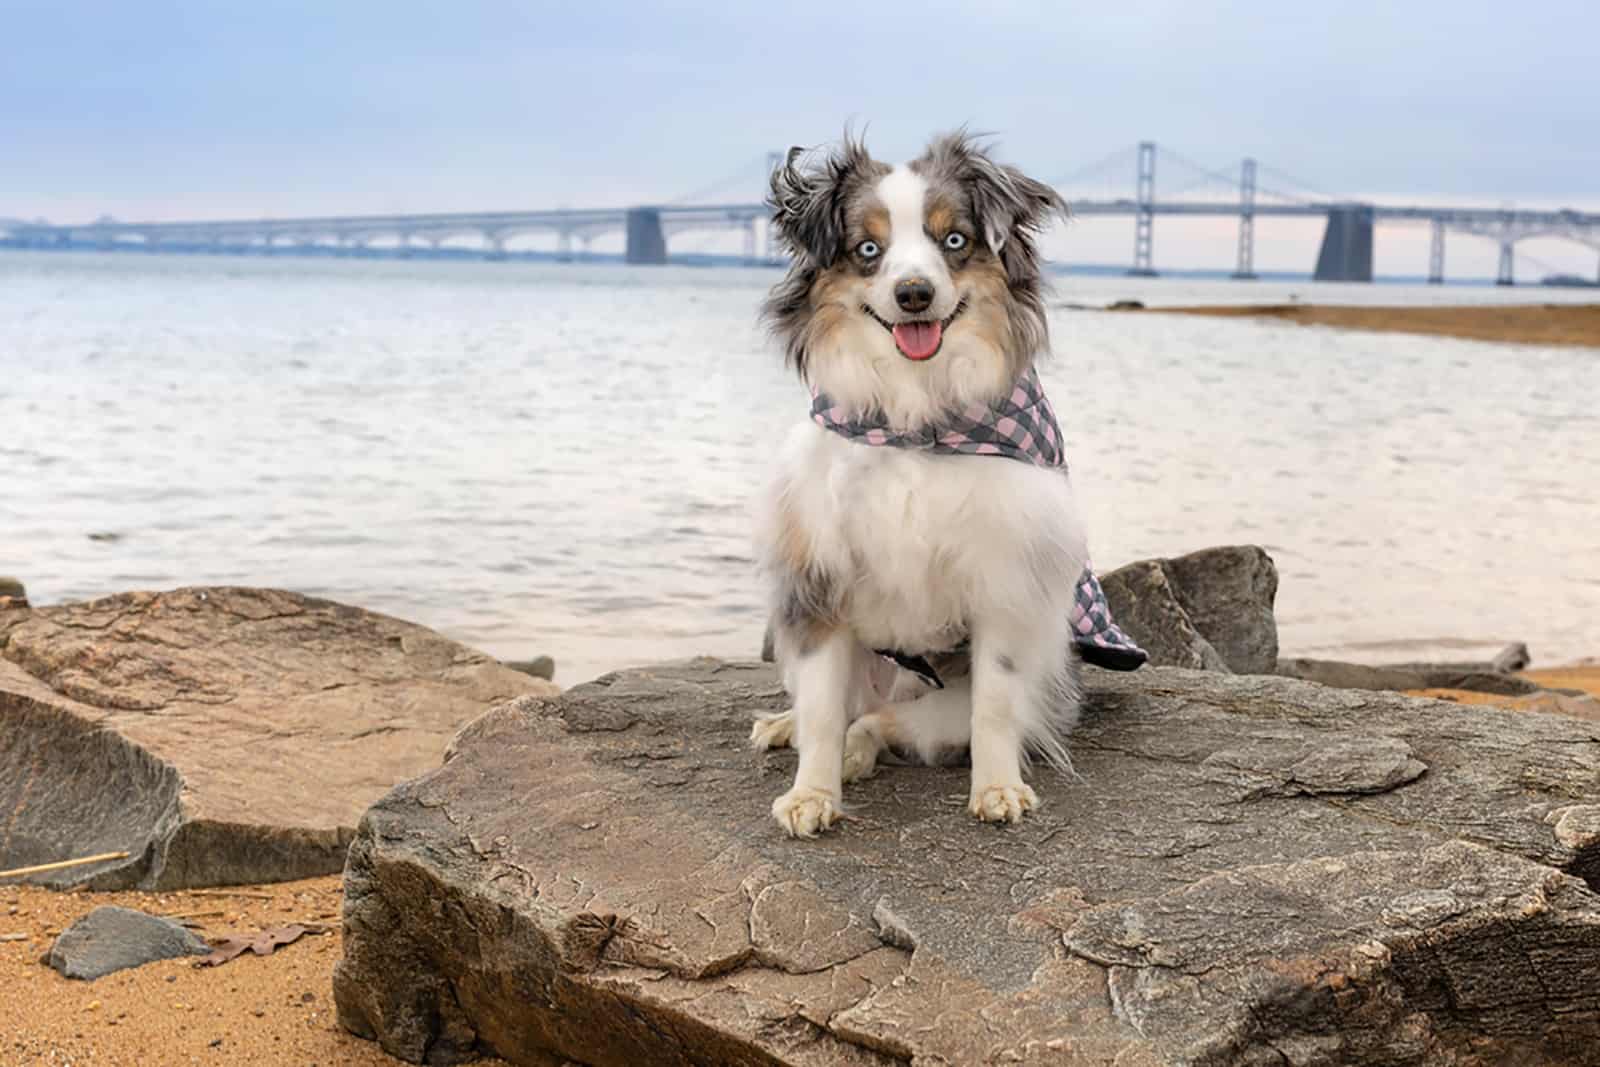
[{"x1": 1101, "y1": 545, "x2": 1278, "y2": 673}]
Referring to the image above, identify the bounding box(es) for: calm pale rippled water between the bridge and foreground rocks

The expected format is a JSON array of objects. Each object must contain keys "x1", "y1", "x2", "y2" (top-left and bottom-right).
[{"x1": 0, "y1": 253, "x2": 1600, "y2": 683}]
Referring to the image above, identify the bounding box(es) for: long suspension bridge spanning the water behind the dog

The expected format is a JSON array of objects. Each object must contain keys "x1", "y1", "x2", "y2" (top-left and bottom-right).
[{"x1": 0, "y1": 141, "x2": 1600, "y2": 285}]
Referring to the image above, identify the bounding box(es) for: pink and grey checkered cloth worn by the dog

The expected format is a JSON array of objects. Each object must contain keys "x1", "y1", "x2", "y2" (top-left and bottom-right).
[{"x1": 811, "y1": 368, "x2": 1149, "y2": 685}]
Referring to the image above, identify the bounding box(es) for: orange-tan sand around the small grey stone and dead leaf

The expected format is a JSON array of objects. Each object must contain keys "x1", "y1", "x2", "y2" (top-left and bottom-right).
[{"x1": 0, "y1": 877, "x2": 506, "y2": 1067}]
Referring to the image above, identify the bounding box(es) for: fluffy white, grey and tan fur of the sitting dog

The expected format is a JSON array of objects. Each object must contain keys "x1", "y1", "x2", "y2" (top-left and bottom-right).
[{"x1": 752, "y1": 133, "x2": 1086, "y2": 837}]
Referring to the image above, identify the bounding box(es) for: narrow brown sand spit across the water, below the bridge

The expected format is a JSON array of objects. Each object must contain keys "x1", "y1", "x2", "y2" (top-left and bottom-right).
[{"x1": 1144, "y1": 302, "x2": 1600, "y2": 347}]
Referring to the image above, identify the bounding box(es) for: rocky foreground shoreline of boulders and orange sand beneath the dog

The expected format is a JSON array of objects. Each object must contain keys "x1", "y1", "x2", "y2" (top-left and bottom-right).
[{"x1": 0, "y1": 559, "x2": 1600, "y2": 1067}]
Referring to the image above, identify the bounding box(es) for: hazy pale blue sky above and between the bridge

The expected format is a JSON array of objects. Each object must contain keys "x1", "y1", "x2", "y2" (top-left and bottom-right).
[{"x1": 0, "y1": 0, "x2": 1600, "y2": 272}]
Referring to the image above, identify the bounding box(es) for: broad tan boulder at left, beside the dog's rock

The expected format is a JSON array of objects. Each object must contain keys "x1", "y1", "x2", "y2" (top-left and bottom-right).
[{"x1": 0, "y1": 589, "x2": 557, "y2": 889}]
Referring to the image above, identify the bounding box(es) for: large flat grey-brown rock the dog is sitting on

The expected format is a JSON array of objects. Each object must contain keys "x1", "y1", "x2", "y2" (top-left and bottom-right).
[{"x1": 334, "y1": 661, "x2": 1600, "y2": 1067}]
